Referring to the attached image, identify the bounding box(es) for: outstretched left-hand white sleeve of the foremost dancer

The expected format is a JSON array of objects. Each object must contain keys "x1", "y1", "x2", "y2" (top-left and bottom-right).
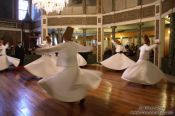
[{"x1": 35, "y1": 44, "x2": 64, "y2": 55}]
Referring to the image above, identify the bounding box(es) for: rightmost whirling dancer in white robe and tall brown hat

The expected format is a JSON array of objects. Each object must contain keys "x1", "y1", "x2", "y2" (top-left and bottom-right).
[{"x1": 122, "y1": 35, "x2": 165, "y2": 85}]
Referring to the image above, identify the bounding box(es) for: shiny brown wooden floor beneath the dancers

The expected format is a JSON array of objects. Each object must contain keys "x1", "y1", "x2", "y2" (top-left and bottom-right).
[{"x1": 0, "y1": 65, "x2": 175, "y2": 116}]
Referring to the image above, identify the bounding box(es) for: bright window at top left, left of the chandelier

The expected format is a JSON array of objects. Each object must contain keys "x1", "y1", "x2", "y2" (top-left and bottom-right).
[{"x1": 18, "y1": 0, "x2": 29, "y2": 20}]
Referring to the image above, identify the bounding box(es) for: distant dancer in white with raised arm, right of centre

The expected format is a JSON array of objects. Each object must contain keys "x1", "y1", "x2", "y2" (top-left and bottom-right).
[{"x1": 101, "y1": 40, "x2": 135, "y2": 70}]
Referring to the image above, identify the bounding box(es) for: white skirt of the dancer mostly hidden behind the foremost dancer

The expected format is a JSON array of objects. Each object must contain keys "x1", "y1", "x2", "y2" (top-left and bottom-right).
[{"x1": 24, "y1": 54, "x2": 87, "y2": 78}]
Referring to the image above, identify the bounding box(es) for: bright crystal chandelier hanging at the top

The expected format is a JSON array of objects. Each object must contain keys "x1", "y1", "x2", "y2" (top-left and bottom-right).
[{"x1": 32, "y1": 0, "x2": 69, "y2": 14}]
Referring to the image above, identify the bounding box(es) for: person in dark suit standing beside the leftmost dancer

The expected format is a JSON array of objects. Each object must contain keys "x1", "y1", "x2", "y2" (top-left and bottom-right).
[{"x1": 15, "y1": 42, "x2": 25, "y2": 66}]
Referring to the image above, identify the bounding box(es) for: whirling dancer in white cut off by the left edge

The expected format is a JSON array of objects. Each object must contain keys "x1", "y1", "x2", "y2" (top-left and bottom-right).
[{"x1": 0, "y1": 40, "x2": 20, "y2": 71}]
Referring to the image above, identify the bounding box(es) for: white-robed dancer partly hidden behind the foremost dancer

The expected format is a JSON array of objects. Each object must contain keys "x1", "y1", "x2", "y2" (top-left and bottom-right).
[{"x1": 24, "y1": 36, "x2": 87, "y2": 78}]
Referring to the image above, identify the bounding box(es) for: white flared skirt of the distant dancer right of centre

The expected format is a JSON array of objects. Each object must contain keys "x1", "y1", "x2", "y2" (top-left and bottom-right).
[{"x1": 101, "y1": 53, "x2": 135, "y2": 70}]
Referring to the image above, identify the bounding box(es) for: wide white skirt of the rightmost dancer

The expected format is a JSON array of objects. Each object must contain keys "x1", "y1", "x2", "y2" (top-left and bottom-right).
[{"x1": 121, "y1": 60, "x2": 165, "y2": 85}]
